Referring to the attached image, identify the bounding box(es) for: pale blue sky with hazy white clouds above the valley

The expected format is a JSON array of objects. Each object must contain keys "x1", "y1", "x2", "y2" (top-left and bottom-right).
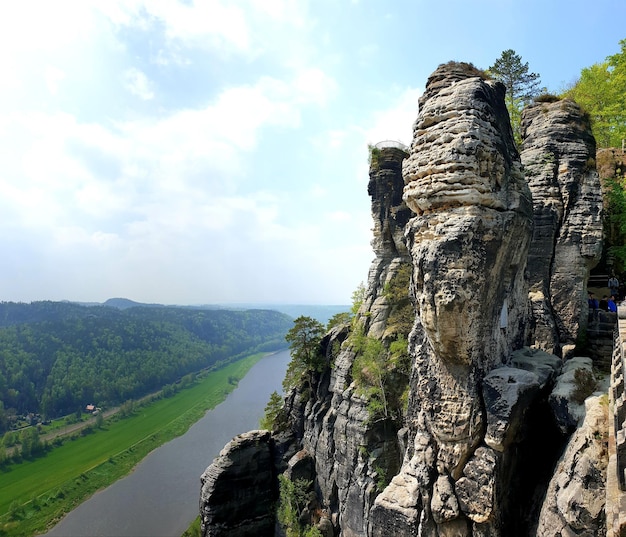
[{"x1": 0, "y1": 0, "x2": 626, "y2": 304}]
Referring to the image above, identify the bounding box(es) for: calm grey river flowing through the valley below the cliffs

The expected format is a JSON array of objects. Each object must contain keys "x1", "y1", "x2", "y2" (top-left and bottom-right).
[{"x1": 41, "y1": 351, "x2": 290, "y2": 537}]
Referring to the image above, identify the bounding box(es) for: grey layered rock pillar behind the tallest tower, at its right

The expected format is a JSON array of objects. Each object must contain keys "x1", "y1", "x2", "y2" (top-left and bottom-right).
[{"x1": 521, "y1": 99, "x2": 602, "y2": 355}]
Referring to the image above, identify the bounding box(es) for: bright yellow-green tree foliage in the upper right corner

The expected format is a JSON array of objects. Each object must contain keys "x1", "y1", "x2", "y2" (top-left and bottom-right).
[{"x1": 564, "y1": 39, "x2": 626, "y2": 147}]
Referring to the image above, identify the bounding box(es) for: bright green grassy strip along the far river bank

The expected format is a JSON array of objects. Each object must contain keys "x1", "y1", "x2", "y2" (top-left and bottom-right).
[{"x1": 0, "y1": 353, "x2": 264, "y2": 537}]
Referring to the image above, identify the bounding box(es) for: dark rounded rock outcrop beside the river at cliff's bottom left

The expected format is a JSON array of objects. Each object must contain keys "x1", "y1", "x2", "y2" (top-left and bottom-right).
[{"x1": 200, "y1": 431, "x2": 278, "y2": 537}]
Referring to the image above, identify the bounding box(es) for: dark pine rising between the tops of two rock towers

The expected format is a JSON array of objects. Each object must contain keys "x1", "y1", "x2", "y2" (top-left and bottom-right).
[{"x1": 489, "y1": 49, "x2": 542, "y2": 146}]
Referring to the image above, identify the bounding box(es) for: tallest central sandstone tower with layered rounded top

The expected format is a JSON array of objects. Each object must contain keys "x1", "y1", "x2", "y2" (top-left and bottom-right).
[{"x1": 370, "y1": 64, "x2": 538, "y2": 536}]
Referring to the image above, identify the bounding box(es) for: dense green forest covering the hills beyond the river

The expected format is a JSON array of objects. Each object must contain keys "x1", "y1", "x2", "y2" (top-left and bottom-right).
[{"x1": 0, "y1": 302, "x2": 292, "y2": 432}]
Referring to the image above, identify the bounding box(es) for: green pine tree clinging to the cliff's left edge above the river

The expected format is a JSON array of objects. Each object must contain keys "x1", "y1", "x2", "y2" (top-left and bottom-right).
[{"x1": 283, "y1": 315, "x2": 324, "y2": 391}]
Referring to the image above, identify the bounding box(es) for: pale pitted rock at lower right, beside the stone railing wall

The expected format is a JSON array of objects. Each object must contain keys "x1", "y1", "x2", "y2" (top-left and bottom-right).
[{"x1": 536, "y1": 396, "x2": 608, "y2": 537}]
